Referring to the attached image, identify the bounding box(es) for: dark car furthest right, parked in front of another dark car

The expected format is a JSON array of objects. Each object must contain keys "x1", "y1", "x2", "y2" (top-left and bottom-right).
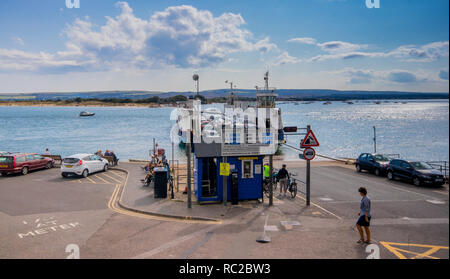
[{"x1": 387, "y1": 159, "x2": 445, "y2": 186}]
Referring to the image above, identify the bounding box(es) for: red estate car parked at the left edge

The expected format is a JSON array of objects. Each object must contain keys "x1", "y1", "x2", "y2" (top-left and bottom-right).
[{"x1": 0, "y1": 153, "x2": 55, "y2": 175}]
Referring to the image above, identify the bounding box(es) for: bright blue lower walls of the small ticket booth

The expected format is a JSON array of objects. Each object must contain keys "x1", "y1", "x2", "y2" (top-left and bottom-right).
[{"x1": 194, "y1": 156, "x2": 264, "y2": 202}]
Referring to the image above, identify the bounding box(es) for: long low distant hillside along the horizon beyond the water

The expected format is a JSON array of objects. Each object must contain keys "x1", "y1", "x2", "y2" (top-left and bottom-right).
[{"x1": 0, "y1": 89, "x2": 449, "y2": 101}]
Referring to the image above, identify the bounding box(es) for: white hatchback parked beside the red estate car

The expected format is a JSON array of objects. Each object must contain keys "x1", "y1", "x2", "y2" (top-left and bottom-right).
[{"x1": 61, "y1": 154, "x2": 109, "y2": 177}]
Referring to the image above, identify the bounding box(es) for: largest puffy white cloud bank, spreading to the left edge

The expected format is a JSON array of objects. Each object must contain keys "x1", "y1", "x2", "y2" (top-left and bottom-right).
[{"x1": 0, "y1": 2, "x2": 278, "y2": 71}]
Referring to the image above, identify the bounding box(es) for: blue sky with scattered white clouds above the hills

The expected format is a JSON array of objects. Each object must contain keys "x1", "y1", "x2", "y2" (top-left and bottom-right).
[{"x1": 0, "y1": 0, "x2": 449, "y2": 93}]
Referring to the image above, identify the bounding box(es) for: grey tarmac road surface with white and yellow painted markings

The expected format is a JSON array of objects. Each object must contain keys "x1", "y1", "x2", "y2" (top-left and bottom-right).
[{"x1": 0, "y1": 166, "x2": 449, "y2": 259}]
